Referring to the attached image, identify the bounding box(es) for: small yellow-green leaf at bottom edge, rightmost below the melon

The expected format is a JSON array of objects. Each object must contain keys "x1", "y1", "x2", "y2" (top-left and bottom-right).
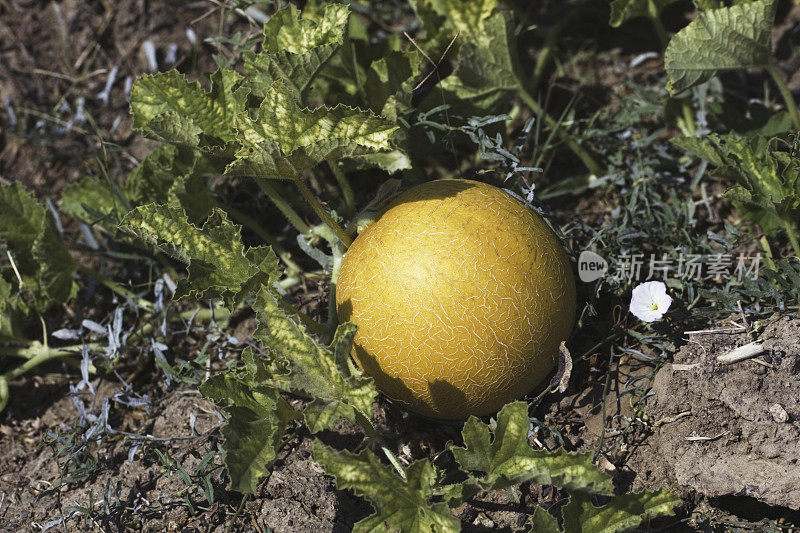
[{"x1": 562, "y1": 490, "x2": 681, "y2": 533}]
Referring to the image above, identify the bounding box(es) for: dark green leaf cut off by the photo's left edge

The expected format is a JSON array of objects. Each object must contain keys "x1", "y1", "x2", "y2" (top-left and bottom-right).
[{"x1": 0, "y1": 182, "x2": 77, "y2": 310}]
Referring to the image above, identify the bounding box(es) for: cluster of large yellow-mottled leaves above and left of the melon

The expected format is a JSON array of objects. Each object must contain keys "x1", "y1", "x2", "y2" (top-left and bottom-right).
[{"x1": 131, "y1": 4, "x2": 406, "y2": 184}]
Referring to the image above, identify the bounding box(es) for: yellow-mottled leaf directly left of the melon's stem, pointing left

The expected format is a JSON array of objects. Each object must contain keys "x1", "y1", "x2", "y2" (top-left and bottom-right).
[{"x1": 120, "y1": 204, "x2": 280, "y2": 308}]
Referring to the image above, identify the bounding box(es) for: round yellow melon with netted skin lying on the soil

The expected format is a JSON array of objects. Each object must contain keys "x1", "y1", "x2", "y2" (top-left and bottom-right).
[{"x1": 336, "y1": 180, "x2": 575, "y2": 420}]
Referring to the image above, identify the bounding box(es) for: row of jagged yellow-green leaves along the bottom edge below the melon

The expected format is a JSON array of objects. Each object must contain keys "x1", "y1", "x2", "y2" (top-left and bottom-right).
[{"x1": 314, "y1": 402, "x2": 680, "y2": 533}]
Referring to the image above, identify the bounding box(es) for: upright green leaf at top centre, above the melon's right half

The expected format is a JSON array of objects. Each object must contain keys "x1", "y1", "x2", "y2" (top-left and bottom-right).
[{"x1": 437, "y1": 11, "x2": 519, "y2": 112}]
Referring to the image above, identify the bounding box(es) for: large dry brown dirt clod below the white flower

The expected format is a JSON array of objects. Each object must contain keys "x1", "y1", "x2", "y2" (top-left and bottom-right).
[{"x1": 631, "y1": 317, "x2": 800, "y2": 509}]
